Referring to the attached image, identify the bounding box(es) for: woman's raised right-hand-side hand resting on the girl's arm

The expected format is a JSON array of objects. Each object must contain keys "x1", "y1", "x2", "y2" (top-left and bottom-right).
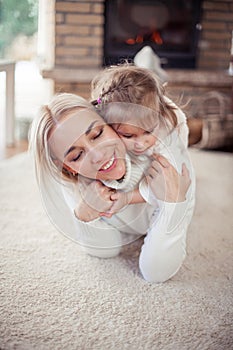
[{"x1": 147, "y1": 155, "x2": 191, "y2": 203}]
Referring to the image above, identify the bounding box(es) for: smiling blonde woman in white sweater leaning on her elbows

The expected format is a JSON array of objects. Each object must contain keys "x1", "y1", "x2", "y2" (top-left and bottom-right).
[{"x1": 31, "y1": 94, "x2": 192, "y2": 282}]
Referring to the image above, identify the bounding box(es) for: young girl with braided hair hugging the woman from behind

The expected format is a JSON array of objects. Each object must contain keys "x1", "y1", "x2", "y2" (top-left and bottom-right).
[{"x1": 92, "y1": 65, "x2": 194, "y2": 211}]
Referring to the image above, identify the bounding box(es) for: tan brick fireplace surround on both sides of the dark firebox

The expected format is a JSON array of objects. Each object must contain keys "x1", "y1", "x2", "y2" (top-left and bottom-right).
[{"x1": 43, "y1": 0, "x2": 233, "y2": 116}]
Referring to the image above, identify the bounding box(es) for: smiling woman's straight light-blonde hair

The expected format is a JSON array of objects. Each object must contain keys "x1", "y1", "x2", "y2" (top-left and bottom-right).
[{"x1": 29, "y1": 93, "x2": 93, "y2": 182}]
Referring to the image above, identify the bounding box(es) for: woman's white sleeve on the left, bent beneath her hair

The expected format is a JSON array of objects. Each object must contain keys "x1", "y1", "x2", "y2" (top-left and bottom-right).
[{"x1": 40, "y1": 176, "x2": 121, "y2": 258}]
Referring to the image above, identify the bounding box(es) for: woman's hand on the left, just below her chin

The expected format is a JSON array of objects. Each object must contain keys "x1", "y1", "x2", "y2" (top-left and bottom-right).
[{"x1": 75, "y1": 181, "x2": 115, "y2": 222}]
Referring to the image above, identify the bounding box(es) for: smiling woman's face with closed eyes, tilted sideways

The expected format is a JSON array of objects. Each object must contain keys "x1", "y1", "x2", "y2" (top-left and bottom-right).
[{"x1": 49, "y1": 109, "x2": 126, "y2": 180}]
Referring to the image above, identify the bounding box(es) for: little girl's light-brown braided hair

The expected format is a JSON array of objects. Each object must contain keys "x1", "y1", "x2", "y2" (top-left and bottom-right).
[{"x1": 91, "y1": 64, "x2": 177, "y2": 128}]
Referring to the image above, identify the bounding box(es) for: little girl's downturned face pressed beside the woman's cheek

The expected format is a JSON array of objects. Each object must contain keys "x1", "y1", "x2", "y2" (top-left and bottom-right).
[{"x1": 113, "y1": 124, "x2": 156, "y2": 155}]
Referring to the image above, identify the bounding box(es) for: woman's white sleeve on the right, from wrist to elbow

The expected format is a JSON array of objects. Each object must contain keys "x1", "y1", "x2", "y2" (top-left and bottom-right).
[{"x1": 139, "y1": 193, "x2": 194, "y2": 283}]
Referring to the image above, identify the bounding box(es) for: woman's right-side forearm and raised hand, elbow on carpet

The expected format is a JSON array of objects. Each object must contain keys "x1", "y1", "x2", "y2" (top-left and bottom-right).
[{"x1": 139, "y1": 152, "x2": 195, "y2": 282}]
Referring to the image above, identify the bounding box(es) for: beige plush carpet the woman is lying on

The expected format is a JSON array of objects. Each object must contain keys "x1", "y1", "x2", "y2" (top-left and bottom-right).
[{"x1": 0, "y1": 150, "x2": 233, "y2": 350}]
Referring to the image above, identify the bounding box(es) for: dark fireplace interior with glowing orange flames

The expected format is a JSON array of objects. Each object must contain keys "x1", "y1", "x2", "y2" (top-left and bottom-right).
[{"x1": 103, "y1": 0, "x2": 201, "y2": 69}]
